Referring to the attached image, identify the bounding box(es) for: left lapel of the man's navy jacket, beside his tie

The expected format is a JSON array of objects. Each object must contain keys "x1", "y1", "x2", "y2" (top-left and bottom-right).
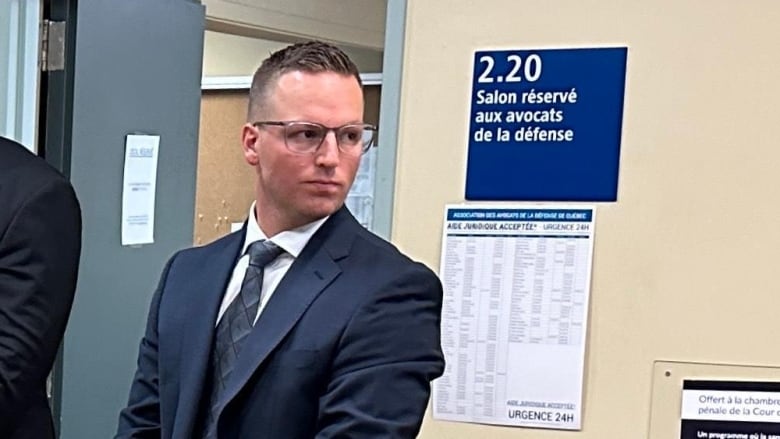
[{"x1": 174, "y1": 232, "x2": 245, "y2": 437}]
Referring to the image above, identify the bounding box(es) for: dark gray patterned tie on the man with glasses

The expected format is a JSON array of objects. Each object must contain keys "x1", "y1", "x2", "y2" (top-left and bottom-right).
[{"x1": 204, "y1": 240, "x2": 284, "y2": 439}]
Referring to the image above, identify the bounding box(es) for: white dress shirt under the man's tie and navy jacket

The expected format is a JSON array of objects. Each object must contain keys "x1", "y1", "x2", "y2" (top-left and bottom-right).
[{"x1": 214, "y1": 203, "x2": 328, "y2": 326}]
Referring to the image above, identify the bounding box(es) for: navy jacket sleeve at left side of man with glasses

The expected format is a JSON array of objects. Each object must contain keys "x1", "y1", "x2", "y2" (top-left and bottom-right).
[{"x1": 115, "y1": 256, "x2": 175, "y2": 439}]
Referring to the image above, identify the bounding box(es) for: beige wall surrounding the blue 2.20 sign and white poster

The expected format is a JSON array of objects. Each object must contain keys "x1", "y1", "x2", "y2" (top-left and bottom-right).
[{"x1": 393, "y1": 0, "x2": 780, "y2": 439}]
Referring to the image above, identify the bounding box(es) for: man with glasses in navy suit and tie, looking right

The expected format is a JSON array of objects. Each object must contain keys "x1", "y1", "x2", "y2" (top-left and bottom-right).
[{"x1": 117, "y1": 42, "x2": 444, "y2": 439}]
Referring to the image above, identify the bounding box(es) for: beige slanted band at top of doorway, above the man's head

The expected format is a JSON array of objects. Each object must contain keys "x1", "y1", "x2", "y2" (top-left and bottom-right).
[{"x1": 203, "y1": 0, "x2": 386, "y2": 50}]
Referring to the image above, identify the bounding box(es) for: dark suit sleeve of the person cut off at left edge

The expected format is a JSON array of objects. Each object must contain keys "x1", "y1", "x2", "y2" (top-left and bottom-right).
[{"x1": 0, "y1": 178, "x2": 81, "y2": 437}]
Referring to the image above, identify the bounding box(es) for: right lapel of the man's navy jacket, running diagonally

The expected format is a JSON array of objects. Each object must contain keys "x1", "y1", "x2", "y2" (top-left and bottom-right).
[{"x1": 218, "y1": 208, "x2": 354, "y2": 407}]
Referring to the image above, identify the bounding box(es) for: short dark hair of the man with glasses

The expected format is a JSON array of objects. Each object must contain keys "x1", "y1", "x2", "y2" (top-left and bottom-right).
[{"x1": 247, "y1": 41, "x2": 363, "y2": 122}]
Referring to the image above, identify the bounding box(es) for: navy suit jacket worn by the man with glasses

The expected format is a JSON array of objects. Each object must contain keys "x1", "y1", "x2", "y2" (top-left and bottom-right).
[{"x1": 116, "y1": 208, "x2": 444, "y2": 439}]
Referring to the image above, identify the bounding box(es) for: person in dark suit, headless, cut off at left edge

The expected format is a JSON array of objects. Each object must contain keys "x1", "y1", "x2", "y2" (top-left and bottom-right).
[{"x1": 0, "y1": 137, "x2": 81, "y2": 439}]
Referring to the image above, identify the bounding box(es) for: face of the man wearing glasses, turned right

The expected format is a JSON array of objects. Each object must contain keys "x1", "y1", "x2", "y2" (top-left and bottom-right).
[{"x1": 243, "y1": 71, "x2": 363, "y2": 235}]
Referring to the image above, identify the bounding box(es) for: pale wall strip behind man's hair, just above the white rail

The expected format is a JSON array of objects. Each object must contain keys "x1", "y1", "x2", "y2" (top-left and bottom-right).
[{"x1": 203, "y1": 31, "x2": 382, "y2": 76}]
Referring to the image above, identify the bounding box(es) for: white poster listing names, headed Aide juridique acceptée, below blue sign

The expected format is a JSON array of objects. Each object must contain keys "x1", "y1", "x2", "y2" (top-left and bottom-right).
[{"x1": 433, "y1": 205, "x2": 595, "y2": 430}]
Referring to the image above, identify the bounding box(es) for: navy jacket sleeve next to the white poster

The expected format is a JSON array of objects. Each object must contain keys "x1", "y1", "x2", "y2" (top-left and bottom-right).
[{"x1": 316, "y1": 264, "x2": 444, "y2": 439}]
